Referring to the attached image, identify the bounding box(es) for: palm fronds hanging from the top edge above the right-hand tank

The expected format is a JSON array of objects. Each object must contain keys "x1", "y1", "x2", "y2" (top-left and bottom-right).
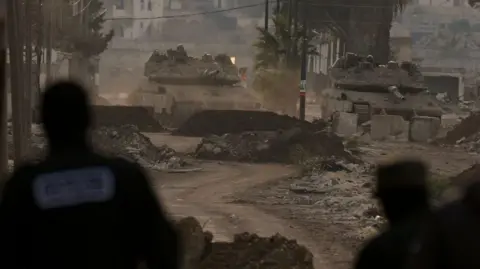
[{"x1": 300, "y1": 0, "x2": 412, "y2": 62}]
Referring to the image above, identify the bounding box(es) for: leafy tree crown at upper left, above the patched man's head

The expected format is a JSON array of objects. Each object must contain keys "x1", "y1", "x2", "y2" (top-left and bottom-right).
[{"x1": 54, "y1": 0, "x2": 113, "y2": 57}]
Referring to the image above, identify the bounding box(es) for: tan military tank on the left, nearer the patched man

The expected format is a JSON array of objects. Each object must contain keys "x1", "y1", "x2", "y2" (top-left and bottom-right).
[{"x1": 128, "y1": 46, "x2": 261, "y2": 127}]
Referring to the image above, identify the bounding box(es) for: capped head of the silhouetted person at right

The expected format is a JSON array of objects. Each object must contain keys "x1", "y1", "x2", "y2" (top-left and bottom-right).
[{"x1": 375, "y1": 160, "x2": 429, "y2": 222}]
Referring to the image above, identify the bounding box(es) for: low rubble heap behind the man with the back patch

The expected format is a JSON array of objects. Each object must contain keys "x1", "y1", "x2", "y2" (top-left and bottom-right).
[{"x1": 8, "y1": 125, "x2": 185, "y2": 169}]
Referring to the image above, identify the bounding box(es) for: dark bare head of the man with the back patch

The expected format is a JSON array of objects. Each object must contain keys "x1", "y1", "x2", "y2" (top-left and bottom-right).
[{"x1": 41, "y1": 80, "x2": 92, "y2": 150}]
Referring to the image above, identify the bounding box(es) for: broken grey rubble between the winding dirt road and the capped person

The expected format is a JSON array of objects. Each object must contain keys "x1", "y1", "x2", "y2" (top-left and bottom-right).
[{"x1": 232, "y1": 159, "x2": 385, "y2": 250}]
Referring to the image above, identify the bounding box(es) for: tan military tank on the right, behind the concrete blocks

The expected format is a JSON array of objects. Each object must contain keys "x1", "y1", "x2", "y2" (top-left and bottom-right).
[{"x1": 320, "y1": 53, "x2": 442, "y2": 123}]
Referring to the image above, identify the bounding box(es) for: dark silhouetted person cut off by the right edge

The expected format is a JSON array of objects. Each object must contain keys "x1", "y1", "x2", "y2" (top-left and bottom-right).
[{"x1": 411, "y1": 178, "x2": 480, "y2": 269}]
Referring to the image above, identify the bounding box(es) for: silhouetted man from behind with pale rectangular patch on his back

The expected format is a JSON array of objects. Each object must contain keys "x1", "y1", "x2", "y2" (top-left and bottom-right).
[{"x1": 0, "y1": 82, "x2": 179, "y2": 269}]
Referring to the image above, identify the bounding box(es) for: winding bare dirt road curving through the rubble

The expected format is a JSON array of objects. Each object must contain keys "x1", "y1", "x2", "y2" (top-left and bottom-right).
[{"x1": 154, "y1": 162, "x2": 348, "y2": 268}]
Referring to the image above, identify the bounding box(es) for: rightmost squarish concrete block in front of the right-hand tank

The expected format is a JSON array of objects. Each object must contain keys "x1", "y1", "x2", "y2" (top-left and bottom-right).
[{"x1": 410, "y1": 116, "x2": 441, "y2": 142}]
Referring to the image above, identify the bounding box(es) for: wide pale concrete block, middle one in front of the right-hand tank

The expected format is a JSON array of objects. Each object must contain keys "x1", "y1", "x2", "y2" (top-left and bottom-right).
[{"x1": 370, "y1": 115, "x2": 409, "y2": 140}]
